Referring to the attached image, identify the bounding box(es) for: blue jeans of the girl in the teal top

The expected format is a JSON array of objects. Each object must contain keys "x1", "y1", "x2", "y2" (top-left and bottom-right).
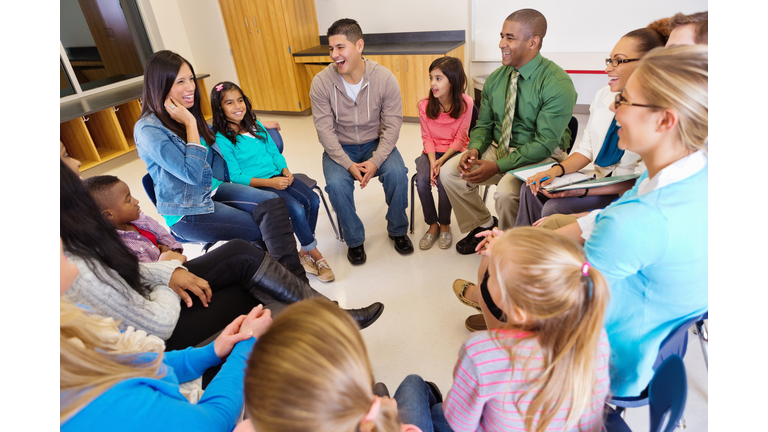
[{"x1": 261, "y1": 179, "x2": 320, "y2": 252}]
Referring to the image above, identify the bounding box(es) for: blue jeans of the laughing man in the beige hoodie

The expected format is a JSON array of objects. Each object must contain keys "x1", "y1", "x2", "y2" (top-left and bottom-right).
[{"x1": 323, "y1": 139, "x2": 408, "y2": 247}]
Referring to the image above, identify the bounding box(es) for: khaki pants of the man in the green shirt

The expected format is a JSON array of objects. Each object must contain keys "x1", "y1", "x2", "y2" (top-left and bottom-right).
[{"x1": 440, "y1": 143, "x2": 568, "y2": 233}]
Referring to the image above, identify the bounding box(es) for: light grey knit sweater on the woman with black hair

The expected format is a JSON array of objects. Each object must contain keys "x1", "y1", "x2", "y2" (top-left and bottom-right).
[{"x1": 64, "y1": 252, "x2": 182, "y2": 340}]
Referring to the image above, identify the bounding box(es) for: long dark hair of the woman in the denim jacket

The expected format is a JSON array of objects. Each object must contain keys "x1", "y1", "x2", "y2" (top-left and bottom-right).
[{"x1": 141, "y1": 50, "x2": 214, "y2": 145}]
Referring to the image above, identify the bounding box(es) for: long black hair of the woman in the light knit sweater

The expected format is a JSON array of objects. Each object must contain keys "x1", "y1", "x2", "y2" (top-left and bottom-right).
[{"x1": 59, "y1": 161, "x2": 149, "y2": 298}]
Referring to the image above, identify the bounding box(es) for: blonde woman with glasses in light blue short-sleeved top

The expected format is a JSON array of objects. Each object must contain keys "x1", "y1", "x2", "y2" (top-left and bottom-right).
[{"x1": 558, "y1": 45, "x2": 709, "y2": 396}]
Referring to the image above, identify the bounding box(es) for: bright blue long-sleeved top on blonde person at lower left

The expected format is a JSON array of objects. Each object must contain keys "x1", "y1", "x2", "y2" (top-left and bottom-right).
[{"x1": 61, "y1": 338, "x2": 256, "y2": 432}]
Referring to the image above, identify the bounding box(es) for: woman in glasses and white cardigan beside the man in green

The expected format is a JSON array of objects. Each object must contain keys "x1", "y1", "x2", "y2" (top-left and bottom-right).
[{"x1": 515, "y1": 21, "x2": 669, "y2": 227}]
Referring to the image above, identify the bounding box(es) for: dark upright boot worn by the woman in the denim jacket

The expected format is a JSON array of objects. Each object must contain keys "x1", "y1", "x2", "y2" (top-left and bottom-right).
[{"x1": 253, "y1": 197, "x2": 309, "y2": 283}]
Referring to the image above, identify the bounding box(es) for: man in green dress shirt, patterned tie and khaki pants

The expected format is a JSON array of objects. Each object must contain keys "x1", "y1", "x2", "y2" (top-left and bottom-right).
[{"x1": 440, "y1": 9, "x2": 577, "y2": 254}]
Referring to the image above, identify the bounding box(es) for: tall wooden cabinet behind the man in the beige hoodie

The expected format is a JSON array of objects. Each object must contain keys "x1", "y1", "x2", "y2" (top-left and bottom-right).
[{"x1": 219, "y1": 0, "x2": 320, "y2": 112}]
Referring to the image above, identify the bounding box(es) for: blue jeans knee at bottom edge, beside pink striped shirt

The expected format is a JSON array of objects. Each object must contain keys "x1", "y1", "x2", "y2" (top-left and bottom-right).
[{"x1": 394, "y1": 375, "x2": 451, "y2": 432}]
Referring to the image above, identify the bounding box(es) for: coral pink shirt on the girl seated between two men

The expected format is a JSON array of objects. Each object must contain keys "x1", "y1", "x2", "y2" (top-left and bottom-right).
[{"x1": 419, "y1": 95, "x2": 473, "y2": 153}]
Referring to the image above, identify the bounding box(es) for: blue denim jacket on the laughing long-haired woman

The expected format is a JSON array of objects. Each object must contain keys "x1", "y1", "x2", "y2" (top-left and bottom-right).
[{"x1": 133, "y1": 114, "x2": 229, "y2": 216}]
